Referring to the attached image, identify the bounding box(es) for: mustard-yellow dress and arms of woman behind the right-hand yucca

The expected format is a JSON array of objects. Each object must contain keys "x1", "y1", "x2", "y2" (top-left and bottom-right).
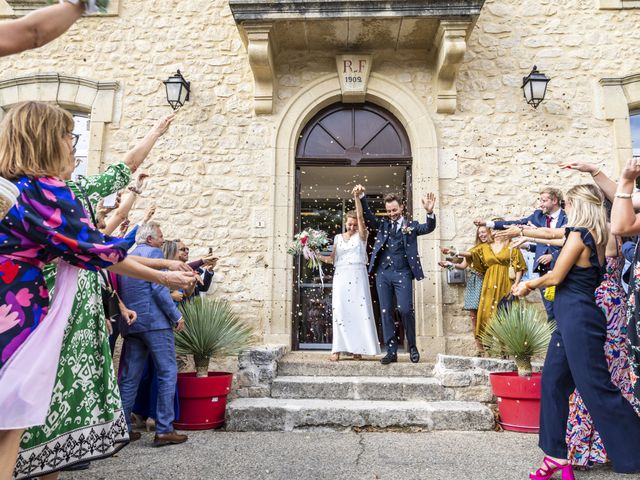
[{"x1": 442, "y1": 229, "x2": 527, "y2": 338}]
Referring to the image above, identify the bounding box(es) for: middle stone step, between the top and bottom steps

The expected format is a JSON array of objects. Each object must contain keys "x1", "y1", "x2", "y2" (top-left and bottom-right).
[{"x1": 271, "y1": 376, "x2": 454, "y2": 401}]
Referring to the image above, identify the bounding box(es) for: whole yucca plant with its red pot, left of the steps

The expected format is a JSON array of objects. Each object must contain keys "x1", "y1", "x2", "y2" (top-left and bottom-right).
[{"x1": 174, "y1": 297, "x2": 253, "y2": 430}]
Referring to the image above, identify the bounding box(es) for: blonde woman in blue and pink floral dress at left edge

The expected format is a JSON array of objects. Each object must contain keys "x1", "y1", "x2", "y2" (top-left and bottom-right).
[{"x1": 0, "y1": 102, "x2": 192, "y2": 479}]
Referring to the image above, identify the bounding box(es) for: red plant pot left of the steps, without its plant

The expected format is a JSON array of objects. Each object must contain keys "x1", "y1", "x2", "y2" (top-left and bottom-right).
[{"x1": 173, "y1": 372, "x2": 233, "y2": 430}]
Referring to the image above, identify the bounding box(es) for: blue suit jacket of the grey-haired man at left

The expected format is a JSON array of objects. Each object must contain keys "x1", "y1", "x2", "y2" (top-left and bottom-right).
[{"x1": 120, "y1": 244, "x2": 182, "y2": 337}]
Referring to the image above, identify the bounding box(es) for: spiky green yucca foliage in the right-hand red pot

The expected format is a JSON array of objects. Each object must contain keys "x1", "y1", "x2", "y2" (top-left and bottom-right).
[{"x1": 480, "y1": 301, "x2": 556, "y2": 376}]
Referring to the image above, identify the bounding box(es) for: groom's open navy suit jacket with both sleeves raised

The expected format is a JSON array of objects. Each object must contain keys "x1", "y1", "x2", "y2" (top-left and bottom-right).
[{"x1": 360, "y1": 197, "x2": 436, "y2": 280}]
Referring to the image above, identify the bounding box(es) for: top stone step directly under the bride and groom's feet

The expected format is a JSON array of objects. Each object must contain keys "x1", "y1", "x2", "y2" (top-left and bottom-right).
[{"x1": 278, "y1": 353, "x2": 433, "y2": 377}]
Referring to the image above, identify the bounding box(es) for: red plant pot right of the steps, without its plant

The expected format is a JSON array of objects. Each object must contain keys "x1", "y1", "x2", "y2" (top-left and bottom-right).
[{"x1": 489, "y1": 372, "x2": 541, "y2": 433}]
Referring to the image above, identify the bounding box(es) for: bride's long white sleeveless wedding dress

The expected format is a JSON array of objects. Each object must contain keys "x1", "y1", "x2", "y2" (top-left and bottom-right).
[{"x1": 331, "y1": 233, "x2": 380, "y2": 355}]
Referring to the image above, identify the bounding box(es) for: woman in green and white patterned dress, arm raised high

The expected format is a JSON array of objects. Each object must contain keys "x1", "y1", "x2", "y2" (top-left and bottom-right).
[{"x1": 15, "y1": 114, "x2": 179, "y2": 480}]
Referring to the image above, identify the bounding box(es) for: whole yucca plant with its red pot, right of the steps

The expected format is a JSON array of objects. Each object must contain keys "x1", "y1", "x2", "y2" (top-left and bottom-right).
[{"x1": 480, "y1": 301, "x2": 555, "y2": 433}]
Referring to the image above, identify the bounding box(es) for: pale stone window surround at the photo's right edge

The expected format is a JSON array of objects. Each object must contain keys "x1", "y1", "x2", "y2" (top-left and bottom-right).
[{"x1": 600, "y1": 73, "x2": 640, "y2": 174}]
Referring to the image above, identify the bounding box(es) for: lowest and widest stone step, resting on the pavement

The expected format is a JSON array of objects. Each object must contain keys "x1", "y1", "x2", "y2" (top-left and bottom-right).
[{"x1": 226, "y1": 398, "x2": 494, "y2": 432}]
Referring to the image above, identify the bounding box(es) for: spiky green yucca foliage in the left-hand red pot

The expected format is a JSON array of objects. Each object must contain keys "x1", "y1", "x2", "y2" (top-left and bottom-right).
[{"x1": 176, "y1": 297, "x2": 254, "y2": 358}]
